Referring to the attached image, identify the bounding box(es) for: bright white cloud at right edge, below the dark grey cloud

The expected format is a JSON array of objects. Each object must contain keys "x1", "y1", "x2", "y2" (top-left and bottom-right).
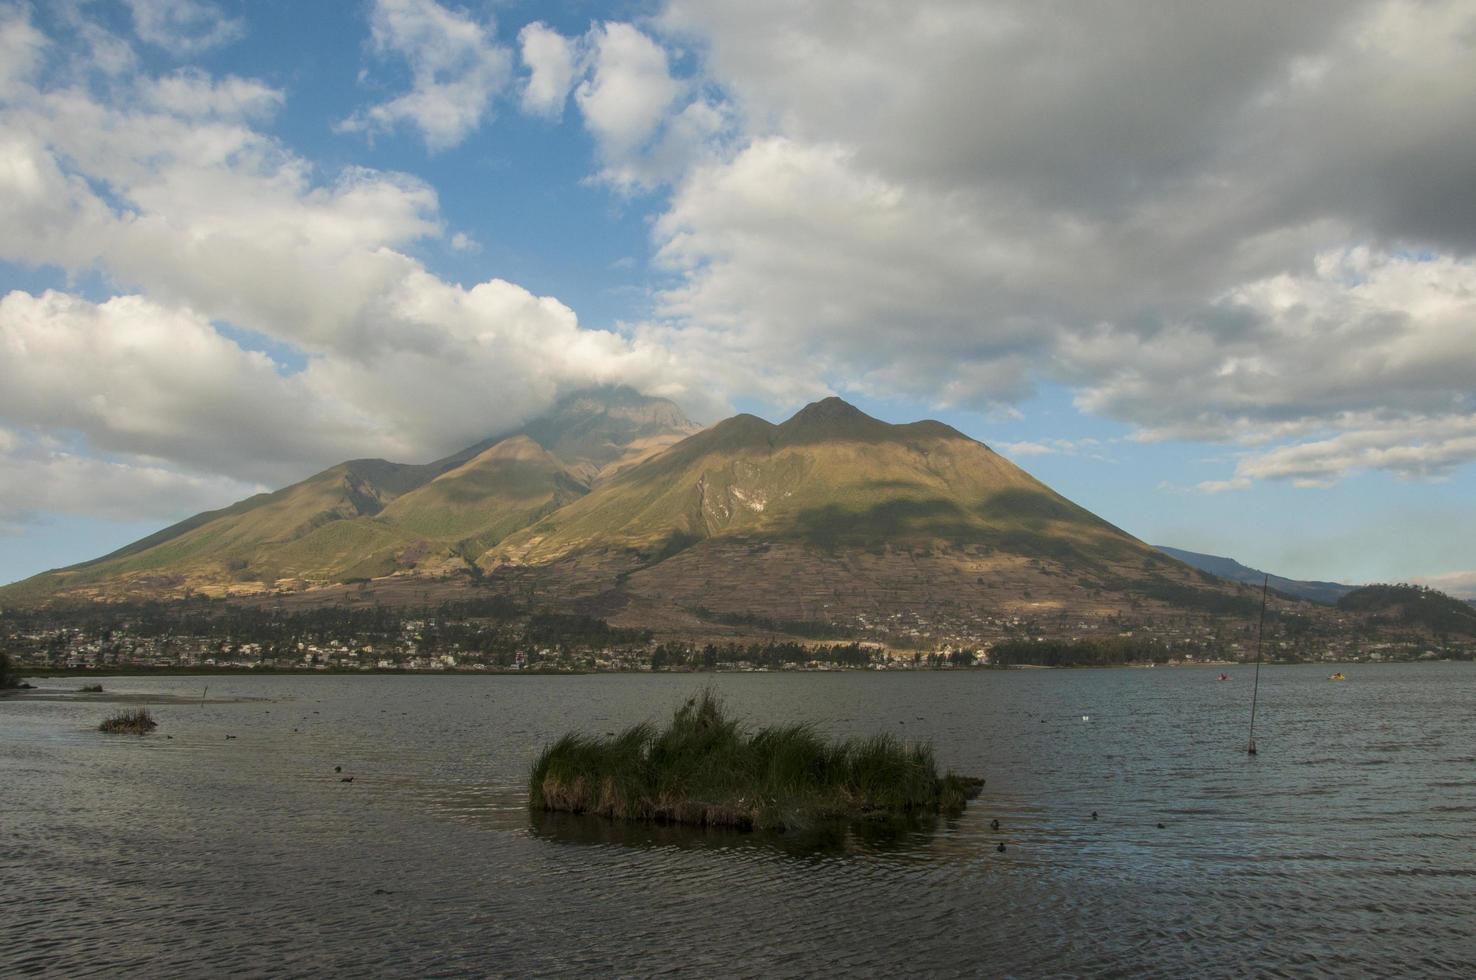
[{"x1": 1061, "y1": 246, "x2": 1476, "y2": 438}]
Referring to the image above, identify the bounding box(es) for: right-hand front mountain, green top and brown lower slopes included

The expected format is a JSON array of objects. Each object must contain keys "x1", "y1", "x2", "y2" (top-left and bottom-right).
[{"x1": 477, "y1": 398, "x2": 1244, "y2": 626}]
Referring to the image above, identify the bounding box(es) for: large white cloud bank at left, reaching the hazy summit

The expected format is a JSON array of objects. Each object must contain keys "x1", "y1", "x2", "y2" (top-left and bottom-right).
[{"x1": 0, "y1": 5, "x2": 702, "y2": 519}]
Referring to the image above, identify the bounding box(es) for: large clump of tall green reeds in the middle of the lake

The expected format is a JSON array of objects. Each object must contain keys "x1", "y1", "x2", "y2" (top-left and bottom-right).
[{"x1": 528, "y1": 691, "x2": 983, "y2": 829}]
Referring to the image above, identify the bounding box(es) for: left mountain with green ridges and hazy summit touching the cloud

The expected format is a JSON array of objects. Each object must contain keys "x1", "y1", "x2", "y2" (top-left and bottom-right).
[{"x1": 0, "y1": 387, "x2": 698, "y2": 601}]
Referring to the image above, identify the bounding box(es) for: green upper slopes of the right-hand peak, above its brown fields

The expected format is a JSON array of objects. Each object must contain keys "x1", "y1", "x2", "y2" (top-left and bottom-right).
[{"x1": 483, "y1": 398, "x2": 1145, "y2": 565}]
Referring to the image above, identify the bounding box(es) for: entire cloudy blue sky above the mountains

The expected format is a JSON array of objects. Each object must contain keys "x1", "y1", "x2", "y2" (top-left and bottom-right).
[{"x1": 0, "y1": 0, "x2": 1476, "y2": 596}]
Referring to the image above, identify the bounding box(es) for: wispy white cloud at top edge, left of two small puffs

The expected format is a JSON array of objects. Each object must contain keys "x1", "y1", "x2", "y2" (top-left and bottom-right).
[{"x1": 338, "y1": 0, "x2": 512, "y2": 152}]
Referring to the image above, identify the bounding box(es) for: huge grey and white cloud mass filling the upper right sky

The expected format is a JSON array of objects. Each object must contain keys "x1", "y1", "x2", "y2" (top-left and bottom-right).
[{"x1": 640, "y1": 0, "x2": 1476, "y2": 489}]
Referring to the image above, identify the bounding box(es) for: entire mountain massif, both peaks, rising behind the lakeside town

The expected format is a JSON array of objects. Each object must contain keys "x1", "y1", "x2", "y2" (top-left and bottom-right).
[{"x1": 0, "y1": 387, "x2": 1476, "y2": 658}]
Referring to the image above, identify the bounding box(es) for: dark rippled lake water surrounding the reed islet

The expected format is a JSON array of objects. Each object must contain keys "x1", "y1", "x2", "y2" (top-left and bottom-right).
[{"x1": 0, "y1": 664, "x2": 1476, "y2": 977}]
